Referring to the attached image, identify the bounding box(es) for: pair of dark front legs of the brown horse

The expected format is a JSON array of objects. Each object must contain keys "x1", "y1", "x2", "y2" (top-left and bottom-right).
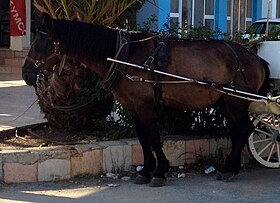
[{"x1": 135, "y1": 108, "x2": 169, "y2": 187}]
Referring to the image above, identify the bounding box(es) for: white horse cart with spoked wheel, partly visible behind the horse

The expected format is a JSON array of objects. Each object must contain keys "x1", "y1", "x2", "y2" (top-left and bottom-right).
[{"x1": 249, "y1": 41, "x2": 280, "y2": 168}]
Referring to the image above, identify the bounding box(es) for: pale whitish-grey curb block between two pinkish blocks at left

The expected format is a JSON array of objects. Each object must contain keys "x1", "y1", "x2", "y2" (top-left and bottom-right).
[{"x1": 38, "y1": 159, "x2": 70, "y2": 181}]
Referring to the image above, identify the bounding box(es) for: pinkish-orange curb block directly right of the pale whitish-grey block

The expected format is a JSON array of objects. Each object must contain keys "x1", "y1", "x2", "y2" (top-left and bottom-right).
[{"x1": 71, "y1": 149, "x2": 103, "y2": 177}]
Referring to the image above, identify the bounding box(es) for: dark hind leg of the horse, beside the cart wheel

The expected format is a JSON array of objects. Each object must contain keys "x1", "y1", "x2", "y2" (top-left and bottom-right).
[{"x1": 217, "y1": 102, "x2": 255, "y2": 180}]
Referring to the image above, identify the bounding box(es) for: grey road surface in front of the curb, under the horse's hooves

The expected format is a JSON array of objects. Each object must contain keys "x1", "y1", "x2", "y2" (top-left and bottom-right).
[{"x1": 0, "y1": 168, "x2": 280, "y2": 203}]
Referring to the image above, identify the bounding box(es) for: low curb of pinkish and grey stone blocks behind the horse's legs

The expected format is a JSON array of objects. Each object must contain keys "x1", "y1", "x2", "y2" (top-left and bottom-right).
[{"x1": 0, "y1": 136, "x2": 249, "y2": 184}]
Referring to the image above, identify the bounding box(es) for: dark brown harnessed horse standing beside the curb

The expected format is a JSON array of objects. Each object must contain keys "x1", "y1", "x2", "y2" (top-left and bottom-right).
[{"x1": 22, "y1": 14, "x2": 269, "y2": 187}]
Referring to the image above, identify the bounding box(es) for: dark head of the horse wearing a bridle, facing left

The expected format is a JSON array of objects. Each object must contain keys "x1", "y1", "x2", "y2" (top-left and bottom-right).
[{"x1": 22, "y1": 14, "x2": 62, "y2": 86}]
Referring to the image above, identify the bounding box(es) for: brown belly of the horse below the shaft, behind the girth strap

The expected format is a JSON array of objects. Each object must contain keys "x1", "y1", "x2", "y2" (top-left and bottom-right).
[{"x1": 162, "y1": 84, "x2": 222, "y2": 110}]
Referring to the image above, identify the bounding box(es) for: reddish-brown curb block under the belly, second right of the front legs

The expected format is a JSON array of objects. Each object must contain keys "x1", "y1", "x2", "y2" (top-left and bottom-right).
[{"x1": 185, "y1": 139, "x2": 210, "y2": 163}]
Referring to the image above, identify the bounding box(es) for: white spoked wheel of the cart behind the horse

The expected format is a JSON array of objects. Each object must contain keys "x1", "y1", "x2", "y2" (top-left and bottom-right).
[{"x1": 249, "y1": 114, "x2": 280, "y2": 168}]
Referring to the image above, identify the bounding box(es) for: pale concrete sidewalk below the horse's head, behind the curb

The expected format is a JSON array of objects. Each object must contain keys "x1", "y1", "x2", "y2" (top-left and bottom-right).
[{"x1": 0, "y1": 73, "x2": 46, "y2": 131}]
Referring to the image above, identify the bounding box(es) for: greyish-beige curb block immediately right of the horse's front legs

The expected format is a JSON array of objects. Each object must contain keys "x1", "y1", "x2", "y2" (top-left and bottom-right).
[{"x1": 163, "y1": 140, "x2": 186, "y2": 166}]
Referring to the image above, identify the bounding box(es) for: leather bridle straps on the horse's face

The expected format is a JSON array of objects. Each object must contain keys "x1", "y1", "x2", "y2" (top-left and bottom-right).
[{"x1": 26, "y1": 30, "x2": 62, "y2": 83}]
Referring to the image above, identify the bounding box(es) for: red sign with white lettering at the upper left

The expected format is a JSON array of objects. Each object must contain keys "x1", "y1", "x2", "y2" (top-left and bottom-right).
[{"x1": 10, "y1": 0, "x2": 26, "y2": 36}]
